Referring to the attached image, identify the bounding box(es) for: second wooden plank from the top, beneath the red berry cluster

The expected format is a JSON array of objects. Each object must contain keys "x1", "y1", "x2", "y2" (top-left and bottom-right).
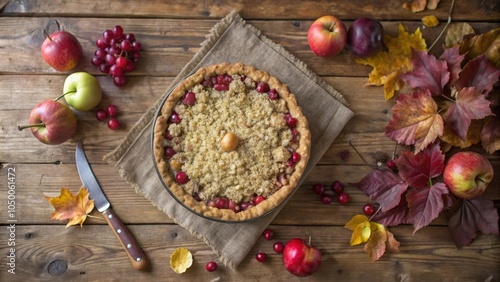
[{"x1": 0, "y1": 17, "x2": 498, "y2": 76}]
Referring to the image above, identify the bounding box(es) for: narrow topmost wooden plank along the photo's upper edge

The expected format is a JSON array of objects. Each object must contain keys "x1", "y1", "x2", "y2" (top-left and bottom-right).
[{"x1": 0, "y1": 0, "x2": 500, "y2": 21}]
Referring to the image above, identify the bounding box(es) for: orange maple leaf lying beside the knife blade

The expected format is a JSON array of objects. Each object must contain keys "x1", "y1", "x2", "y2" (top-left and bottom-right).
[{"x1": 45, "y1": 187, "x2": 94, "y2": 228}]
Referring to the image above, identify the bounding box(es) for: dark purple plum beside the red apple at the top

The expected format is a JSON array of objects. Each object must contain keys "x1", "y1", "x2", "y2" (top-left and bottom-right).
[{"x1": 347, "y1": 18, "x2": 384, "y2": 57}]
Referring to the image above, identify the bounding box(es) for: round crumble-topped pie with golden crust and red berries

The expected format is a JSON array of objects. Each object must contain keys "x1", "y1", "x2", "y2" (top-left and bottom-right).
[{"x1": 152, "y1": 63, "x2": 311, "y2": 222}]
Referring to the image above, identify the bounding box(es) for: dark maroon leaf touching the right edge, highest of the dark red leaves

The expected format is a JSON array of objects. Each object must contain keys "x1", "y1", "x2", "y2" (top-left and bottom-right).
[{"x1": 455, "y1": 54, "x2": 500, "y2": 94}]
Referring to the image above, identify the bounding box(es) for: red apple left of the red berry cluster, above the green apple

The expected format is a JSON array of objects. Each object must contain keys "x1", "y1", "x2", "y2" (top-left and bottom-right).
[{"x1": 42, "y1": 30, "x2": 83, "y2": 71}]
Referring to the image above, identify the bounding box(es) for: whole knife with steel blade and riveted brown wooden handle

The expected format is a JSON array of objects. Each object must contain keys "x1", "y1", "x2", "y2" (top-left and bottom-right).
[{"x1": 75, "y1": 141, "x2": 148, "y2": 270}]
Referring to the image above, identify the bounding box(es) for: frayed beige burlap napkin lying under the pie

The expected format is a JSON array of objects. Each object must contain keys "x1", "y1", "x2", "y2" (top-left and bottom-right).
[{"x1": 104, "y1": 12, "x2": 353, "y2": 269}]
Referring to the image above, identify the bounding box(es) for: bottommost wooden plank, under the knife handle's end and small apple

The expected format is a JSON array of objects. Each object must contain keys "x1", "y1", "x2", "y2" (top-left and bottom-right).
[{"x1": 0, "y1": 224, "x2": 500, "y2": 281}]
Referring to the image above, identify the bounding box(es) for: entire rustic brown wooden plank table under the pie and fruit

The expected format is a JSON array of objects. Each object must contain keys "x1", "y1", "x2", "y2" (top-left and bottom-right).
[{"x1": 0, "y1": 0, "x2": 500, "y2": 281}]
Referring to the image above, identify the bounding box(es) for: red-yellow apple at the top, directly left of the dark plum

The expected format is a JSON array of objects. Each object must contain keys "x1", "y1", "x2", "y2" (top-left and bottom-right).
[{"x1": 307, "y1": 16, "x2": 347, "y2": 57}]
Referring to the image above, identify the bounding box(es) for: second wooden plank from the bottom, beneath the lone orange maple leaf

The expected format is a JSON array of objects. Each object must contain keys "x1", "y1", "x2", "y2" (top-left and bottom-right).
[{"x1": 0, "y1": 163, "x2": 500, "y2": 226}]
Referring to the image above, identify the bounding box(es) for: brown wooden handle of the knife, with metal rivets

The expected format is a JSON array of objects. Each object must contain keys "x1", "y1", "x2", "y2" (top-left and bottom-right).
[{"x1": 102, "y1": 209, "x2": 148, "y2": 270}]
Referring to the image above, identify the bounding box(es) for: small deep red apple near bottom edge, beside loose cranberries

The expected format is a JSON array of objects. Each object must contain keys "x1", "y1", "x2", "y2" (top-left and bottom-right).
[{"x1": 283, "y1": 238, "x2": 321, "y2": 277}]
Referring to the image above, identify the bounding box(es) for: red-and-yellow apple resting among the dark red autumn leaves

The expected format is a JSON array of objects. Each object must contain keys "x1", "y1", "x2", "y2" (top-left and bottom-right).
[{"x1": 443, "y1": 151, "x2": 493, "y2": 199}]
